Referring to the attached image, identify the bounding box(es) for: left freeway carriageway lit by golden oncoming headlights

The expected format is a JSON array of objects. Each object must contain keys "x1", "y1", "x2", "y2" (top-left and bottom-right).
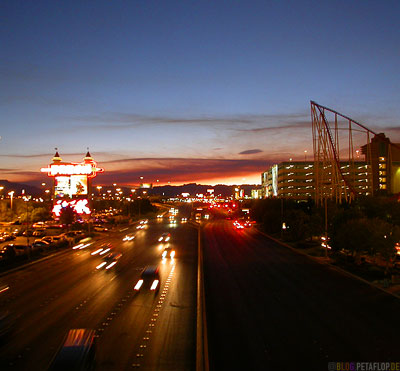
[{"x1": 0, "y1": 219, "x2": 197, "y2": 370}]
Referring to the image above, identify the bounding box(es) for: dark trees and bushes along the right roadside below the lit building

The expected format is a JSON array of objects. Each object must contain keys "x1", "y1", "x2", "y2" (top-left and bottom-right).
[{"x1": 247, "y1": 197, "x2": 400, "y2": 281}]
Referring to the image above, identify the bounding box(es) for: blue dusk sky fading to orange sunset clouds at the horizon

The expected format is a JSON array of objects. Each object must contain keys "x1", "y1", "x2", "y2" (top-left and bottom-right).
[{"x1": 0, "y1": 0, "x2": 400, "y2": 185}]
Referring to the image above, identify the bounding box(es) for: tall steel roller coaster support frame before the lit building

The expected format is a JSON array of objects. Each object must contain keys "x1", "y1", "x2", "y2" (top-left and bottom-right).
[{"x1": 310, "y1": 101, "x2": 378, "y2": 205}]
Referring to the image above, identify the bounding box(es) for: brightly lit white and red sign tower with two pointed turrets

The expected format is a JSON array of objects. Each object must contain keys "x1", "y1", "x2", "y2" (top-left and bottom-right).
[{"x1": 40, "y1": 150, "x2": 104, "y2": 216}]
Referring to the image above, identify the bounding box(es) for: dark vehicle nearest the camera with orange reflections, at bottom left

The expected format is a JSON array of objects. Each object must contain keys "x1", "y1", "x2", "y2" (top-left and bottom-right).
[{"x1": 49, "y1": 329, "x2": 96, "y2": 371}]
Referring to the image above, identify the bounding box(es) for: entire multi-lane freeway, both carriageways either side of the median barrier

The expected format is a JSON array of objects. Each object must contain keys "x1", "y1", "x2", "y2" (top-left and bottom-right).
[{"x1": 0, "y1": 206, "x2": 400, "y2": 371}]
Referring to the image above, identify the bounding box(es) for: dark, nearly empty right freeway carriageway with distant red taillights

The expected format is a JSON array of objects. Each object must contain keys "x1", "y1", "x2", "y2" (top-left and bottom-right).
[{"x1": 202, "y1": 219, "x2": 400, "y2": 371}]
